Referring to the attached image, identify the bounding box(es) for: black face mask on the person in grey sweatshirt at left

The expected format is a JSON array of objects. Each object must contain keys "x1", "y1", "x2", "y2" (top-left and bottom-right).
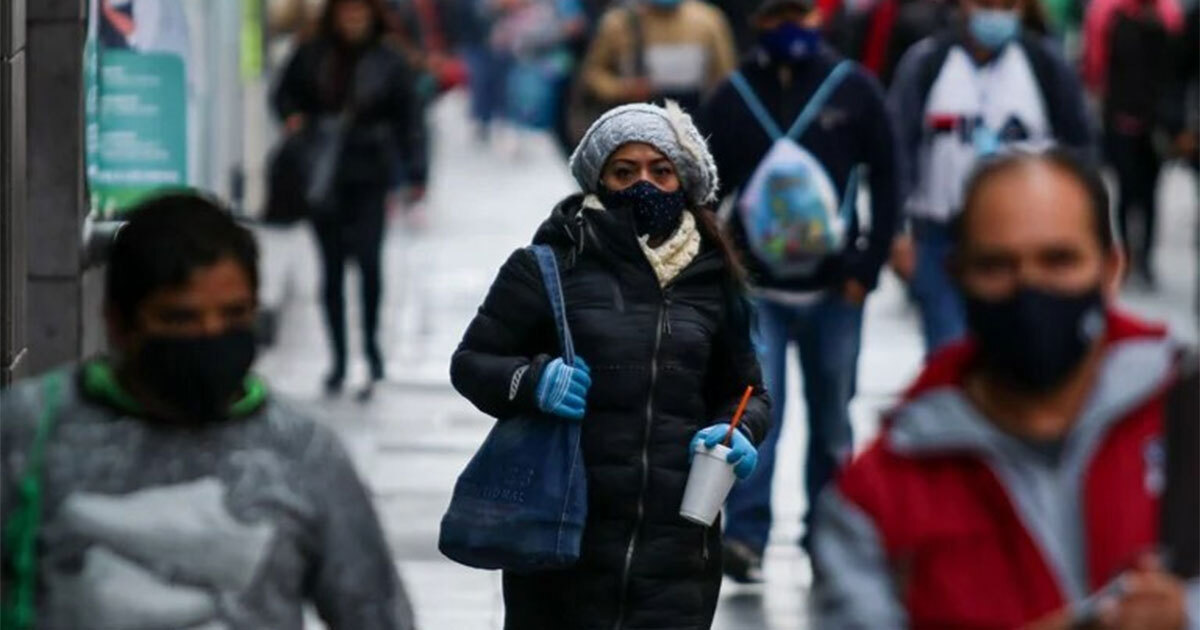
[{"x1": 136, "y1": 329, "x2": 257, "y2": 421}]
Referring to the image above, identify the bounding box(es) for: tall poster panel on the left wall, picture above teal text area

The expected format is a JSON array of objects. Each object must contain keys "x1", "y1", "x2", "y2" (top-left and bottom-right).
[{"x1": 84, "y1": 0, "x2": 188, "y2": 217}]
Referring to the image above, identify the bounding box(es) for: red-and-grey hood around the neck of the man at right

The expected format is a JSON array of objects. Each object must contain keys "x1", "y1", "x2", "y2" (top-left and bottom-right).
[{"x1": 884, "y1": 310, "x2": 1178, "y2": 454}]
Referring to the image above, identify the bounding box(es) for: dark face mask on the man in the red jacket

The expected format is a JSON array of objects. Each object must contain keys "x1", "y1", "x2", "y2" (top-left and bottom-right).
[{"x1": 966, "y1": 287, "x2": 1105, "y2": 394}]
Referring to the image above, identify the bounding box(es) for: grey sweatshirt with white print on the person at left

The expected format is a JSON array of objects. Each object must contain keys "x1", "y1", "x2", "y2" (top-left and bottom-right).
[{"x1": 0, "y1": 362, "x2": 413, "y2": 630}]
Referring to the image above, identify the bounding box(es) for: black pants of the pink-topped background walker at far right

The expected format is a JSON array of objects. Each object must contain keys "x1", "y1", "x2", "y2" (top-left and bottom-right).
[{"x1": 1106, "y1": 128, "x2": 1162, "y2": 272}]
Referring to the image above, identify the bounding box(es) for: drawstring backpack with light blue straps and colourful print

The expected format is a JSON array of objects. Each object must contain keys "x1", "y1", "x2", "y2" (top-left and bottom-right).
[{"x1": 730, "y1": 61, "x2": 859, "y2": 280}]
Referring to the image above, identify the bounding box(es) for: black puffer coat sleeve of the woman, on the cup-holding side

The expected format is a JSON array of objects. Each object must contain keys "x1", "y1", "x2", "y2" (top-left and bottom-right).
[{"x1": 704, "y1": 297, "x2": 770, "y2": 445}]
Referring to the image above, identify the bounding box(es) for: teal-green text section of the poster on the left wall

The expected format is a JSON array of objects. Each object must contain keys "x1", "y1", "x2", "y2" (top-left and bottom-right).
[{"x1": 88, "y1": 48, "x2": 187, "y2": 217}]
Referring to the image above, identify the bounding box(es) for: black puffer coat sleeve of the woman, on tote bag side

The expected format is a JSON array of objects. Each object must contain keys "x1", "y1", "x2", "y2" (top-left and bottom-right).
[{"x1": 450, "y1": 250, "x2": 554, "y2": 419}]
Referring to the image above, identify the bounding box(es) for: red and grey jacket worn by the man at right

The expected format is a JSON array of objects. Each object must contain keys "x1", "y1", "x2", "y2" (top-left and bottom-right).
[{"x1": 815, "y1": 313, "x2": 1177, "y2": 630}]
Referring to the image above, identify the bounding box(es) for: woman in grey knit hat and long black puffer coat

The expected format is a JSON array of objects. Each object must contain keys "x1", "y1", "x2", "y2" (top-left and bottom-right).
[{"x1": 450, "y1": 103, "x2": 769, "y2": 630}]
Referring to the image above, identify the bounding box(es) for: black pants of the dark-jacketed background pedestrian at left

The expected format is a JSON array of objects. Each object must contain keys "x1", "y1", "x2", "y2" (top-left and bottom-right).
[{"x1": 312, "y1": 185, "x2": 388, "y2": 377}]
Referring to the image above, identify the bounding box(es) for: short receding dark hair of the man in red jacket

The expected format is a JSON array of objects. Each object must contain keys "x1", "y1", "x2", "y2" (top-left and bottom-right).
[{"x1": 950, "y1": 148, "x2": 1116, "y2": 251}]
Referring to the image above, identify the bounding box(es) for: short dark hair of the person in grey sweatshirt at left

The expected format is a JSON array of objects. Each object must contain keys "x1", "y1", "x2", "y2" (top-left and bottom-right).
[{"x1": 104, "y1": 192, "x2": 258, "y2": 324}]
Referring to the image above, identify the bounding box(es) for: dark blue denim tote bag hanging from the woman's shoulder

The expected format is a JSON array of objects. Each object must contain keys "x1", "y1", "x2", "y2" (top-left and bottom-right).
[{"x1": 438, "y1": 245, "x2": 588, "y2": 572}]
